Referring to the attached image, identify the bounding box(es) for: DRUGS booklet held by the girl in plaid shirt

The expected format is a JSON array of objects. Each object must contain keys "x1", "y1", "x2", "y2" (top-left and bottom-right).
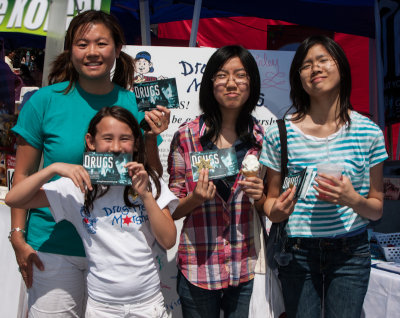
[{"x1": 190, "y1": 147, "x2": 239, "y2": 181}]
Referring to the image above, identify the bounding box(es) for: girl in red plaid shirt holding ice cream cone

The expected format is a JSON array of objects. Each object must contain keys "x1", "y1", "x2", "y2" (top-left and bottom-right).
[{"x1": 168, "y1": 45, "x2": 265, "y2": 317}]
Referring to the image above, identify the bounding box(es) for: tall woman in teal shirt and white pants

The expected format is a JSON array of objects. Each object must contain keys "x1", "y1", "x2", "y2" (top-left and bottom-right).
[{"x1": 10, "y1": 10, "x2": 169, "y2": 317}]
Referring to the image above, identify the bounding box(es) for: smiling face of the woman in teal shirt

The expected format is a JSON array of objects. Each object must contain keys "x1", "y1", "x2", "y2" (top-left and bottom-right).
[{"x1": 71, "y1": 23, "x2": 121, "y2": 86}]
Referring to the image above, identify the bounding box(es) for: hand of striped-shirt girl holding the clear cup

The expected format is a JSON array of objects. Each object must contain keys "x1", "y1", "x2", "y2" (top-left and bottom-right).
[{"x1": 314, "y1": 173, "x2": 359, "y2": 206}]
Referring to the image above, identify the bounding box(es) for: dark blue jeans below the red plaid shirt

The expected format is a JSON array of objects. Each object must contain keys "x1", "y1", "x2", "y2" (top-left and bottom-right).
[{"x1": 177, "y1": 271, "x2": 253, "y2": 318}]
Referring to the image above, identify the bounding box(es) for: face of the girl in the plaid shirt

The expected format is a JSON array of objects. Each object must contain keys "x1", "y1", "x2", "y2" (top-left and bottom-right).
[{"x1": 213, "y1": 57, "x2": 250, "y2": 113}]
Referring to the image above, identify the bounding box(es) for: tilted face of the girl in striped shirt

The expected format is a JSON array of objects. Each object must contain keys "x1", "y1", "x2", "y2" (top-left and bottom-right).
[{"x1": 299, "y1": 44, "x2": 340, "y2": 97}]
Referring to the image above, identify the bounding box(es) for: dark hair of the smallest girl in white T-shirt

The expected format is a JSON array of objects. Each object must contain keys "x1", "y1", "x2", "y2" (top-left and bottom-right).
[{"x1": 84, "y1": 106, "x2": 161, "y2": 216}]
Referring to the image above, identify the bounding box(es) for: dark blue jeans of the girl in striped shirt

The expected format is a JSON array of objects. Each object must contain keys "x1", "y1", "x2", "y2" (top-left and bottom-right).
[{"x1": 279, "y1": 231, "x2": 371, "y2": 318}]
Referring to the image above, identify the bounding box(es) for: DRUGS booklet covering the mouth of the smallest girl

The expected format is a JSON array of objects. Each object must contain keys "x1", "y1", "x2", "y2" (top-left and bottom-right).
[{"x1": 83, "y1": 152, "x2": 132, "y2": 185}]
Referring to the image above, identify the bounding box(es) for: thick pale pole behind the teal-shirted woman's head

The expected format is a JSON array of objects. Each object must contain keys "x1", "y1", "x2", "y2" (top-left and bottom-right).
[{"x1": 42, "y1": 0, "x2": 68, "y2": 86}]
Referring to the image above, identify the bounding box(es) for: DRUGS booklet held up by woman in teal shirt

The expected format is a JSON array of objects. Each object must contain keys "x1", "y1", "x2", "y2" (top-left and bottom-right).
[{"x1": 134, "y1": 78, "x2": 179, "y2": 111}]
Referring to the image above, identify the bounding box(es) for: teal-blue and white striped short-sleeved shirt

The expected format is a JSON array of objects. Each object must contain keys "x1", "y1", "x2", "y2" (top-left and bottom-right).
[{"x1": 260, "y1": 111, "x2": 388, "y2": 237}]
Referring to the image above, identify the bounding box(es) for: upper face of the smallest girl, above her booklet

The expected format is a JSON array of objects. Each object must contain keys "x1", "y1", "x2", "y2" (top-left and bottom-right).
[{"x1": 85, "y1": 116, "x2": 135, "y2": 153}]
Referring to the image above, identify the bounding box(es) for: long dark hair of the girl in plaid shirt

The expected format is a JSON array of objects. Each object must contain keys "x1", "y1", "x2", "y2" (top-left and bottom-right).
[{"x1": 200, "y1": 45, "x2": 260, "y2": 147}]
